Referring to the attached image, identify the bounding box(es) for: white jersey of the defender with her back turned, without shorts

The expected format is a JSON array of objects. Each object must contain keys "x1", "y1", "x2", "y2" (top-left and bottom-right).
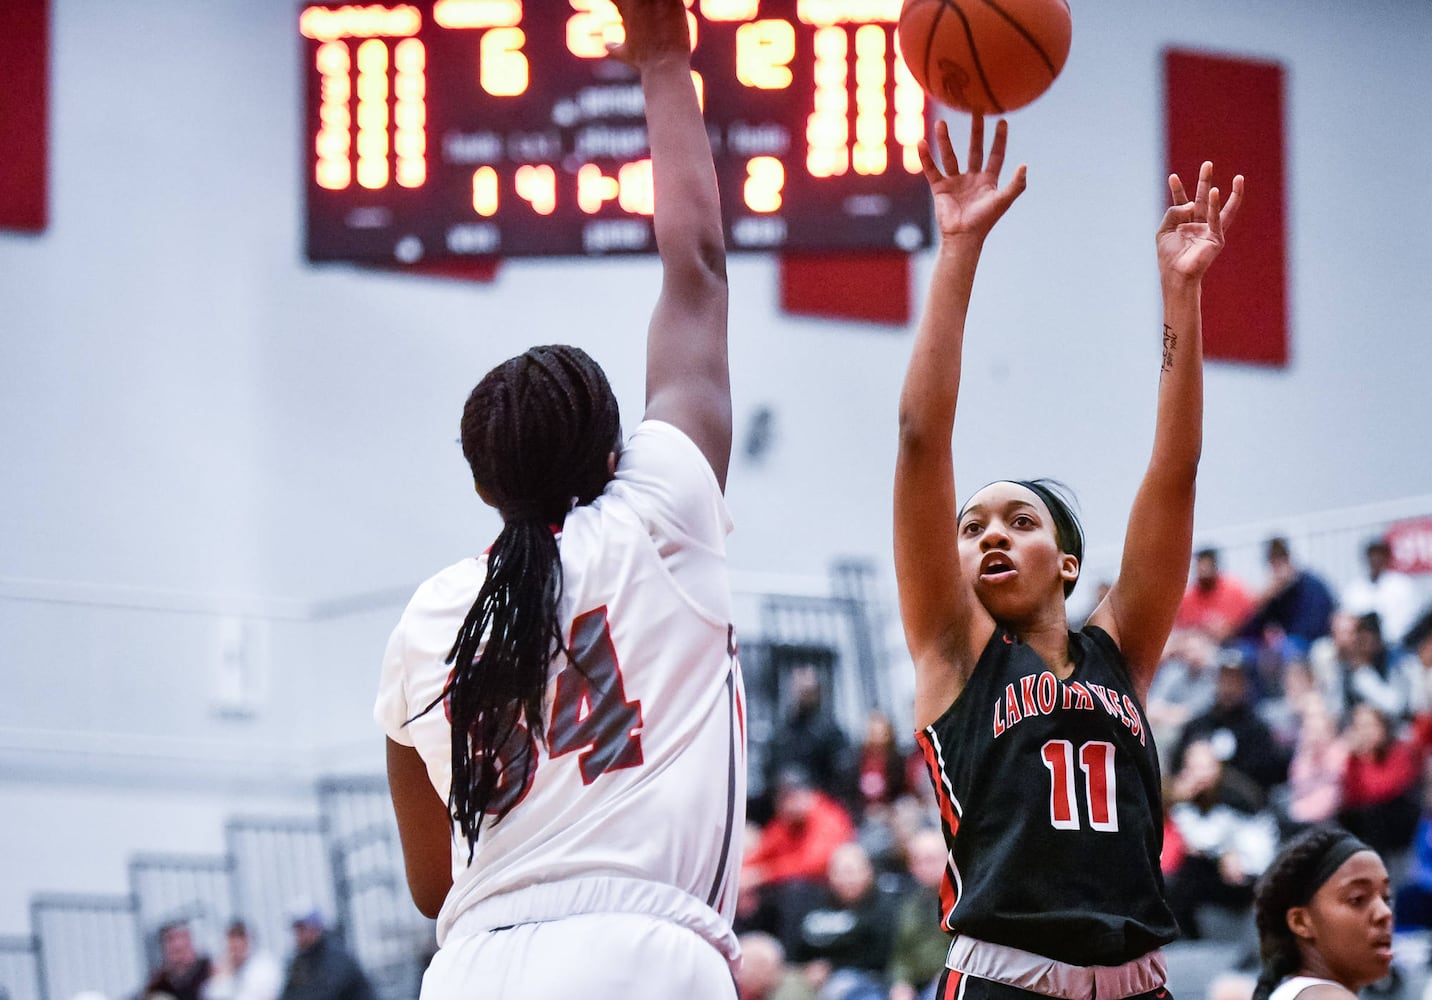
[{"x1": 374, "y1": 421, "x2": 746, "y2": 960}]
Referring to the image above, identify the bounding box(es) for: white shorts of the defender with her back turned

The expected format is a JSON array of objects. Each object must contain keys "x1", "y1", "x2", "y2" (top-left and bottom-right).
[{"x1": 420, "y1": 913, "x2": 736, "y2": 1000}]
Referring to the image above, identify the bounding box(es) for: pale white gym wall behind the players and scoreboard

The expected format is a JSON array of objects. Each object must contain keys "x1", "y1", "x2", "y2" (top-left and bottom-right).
[{"x1": 0, "y1": 0, "x2": 1432, "y2": 933}]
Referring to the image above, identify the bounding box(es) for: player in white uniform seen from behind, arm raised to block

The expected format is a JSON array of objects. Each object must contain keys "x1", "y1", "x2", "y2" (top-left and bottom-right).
[{"x1": 374, "y1": 0, "x2": 746, "y2": 1000}]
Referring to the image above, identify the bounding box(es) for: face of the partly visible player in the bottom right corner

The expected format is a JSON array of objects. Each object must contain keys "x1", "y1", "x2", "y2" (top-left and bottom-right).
[{"x1": 1287, "y1": 851, "x2": 1392, "y2": 993}]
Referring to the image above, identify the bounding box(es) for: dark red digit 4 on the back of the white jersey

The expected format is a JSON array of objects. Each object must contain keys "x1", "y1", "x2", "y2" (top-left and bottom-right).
[{"x1": 547, "y1": 607, "x2": 642, "y2": 785}]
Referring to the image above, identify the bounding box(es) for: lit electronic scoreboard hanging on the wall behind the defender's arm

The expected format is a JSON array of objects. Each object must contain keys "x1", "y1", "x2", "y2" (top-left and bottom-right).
[{"x1": 299, "y1": 0, "x2": 931, "y2": 264}]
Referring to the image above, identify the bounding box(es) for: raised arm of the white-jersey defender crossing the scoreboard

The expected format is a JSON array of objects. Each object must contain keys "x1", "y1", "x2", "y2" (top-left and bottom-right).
[{"x1": 611, "y1": 0, "x2": 730, "y2": 489}]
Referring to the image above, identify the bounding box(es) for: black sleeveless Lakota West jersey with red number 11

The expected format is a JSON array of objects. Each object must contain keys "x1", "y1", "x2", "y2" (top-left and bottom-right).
[{"x1": 916, "y1": 626, "x2": 1179, "y2": 966}]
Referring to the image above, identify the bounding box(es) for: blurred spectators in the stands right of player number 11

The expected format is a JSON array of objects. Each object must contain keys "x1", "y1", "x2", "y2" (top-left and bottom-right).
[{"x1": 1147, "y1": 539, "x2": 1432, "y2": 962}]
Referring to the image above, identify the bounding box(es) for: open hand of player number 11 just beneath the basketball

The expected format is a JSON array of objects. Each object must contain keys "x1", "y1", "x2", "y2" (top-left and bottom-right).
[{"x1": 919, "y1": 115, "x2": 1025, "y2": 239}]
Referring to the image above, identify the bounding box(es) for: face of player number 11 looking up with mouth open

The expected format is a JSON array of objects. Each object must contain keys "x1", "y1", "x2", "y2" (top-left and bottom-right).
[{"x1": 959, "y1": 483, "x2": 1078, "y2": 625}]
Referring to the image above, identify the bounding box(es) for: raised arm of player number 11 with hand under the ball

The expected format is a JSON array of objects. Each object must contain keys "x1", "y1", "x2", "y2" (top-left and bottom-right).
[{"x1": 895, "y1": 116, "x2": 1024, "y2": 726}]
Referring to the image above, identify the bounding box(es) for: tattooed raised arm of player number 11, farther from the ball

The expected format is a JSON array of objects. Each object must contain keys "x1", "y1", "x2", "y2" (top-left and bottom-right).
[{"x1": 1090, "y1": 163, "x2": 1243, "y2": 698}]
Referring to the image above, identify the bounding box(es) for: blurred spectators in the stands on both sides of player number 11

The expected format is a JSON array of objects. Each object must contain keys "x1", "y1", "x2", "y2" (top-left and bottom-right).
[{"x1": 737, "y1": 527, "x2": 1432, "y2": 1000}]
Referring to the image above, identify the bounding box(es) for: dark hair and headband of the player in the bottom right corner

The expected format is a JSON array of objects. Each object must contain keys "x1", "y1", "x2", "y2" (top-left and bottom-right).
[{"x1": 1253, "y1": 827, "x2": 1372, "y2": 1000}]
